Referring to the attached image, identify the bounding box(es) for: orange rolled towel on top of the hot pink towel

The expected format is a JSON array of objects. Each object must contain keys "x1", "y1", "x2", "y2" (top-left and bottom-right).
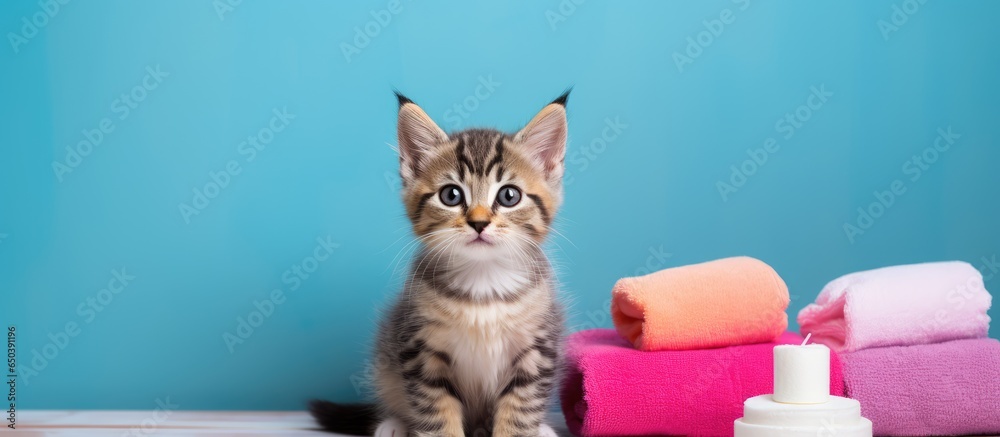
[{"x1": 611, "y1": 256, "x2": 789, "y2": 351}]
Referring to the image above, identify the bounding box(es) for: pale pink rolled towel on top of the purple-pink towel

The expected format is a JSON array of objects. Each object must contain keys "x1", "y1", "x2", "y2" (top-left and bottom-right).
[{"x1": 798, "y1": 261, "x2": 992, "y2": 352}]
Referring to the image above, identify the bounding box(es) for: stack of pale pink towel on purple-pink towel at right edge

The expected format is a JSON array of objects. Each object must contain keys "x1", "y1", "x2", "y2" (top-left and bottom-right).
[{"x1": 798, "y1": 262, "x2": 1000, "y2": 436}]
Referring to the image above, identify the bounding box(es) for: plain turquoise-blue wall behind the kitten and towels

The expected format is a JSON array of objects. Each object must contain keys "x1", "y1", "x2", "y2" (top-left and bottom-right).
[{"x1": 0, "y1": 0, "x2": 1000, "y2": 409}]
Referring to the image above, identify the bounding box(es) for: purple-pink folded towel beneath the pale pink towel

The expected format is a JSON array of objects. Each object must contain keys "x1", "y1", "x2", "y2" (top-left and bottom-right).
[{"x1": 841, "y1": 338, "x2": 1000, "y2": 436}]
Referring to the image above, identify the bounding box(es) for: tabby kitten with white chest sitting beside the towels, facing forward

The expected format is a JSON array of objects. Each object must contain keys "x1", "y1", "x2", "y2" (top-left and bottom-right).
[{"x1": 311, "y1": 92, "x2": 569, "y2": 437}]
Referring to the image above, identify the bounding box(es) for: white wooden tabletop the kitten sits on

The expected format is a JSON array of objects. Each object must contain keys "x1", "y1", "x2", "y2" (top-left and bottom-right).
[{"x1": 7, "y1": 410, "x2": 570, "y2": 437}]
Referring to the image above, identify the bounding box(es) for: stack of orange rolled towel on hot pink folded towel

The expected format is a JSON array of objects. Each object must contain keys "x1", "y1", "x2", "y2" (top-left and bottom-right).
[{"x1": 561, "y1": 257, "x2": 844, "y2": 437}]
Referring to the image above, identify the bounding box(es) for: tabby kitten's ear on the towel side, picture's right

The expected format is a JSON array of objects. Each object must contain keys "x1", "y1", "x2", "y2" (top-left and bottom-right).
[{"x1": 514, "y1": 91, "x2": 569, "y2": 181}]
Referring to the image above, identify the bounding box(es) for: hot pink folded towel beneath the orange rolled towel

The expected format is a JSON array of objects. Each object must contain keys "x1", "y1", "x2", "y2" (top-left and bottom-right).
[{"x1": 561, "y1": 329, "x2": 844, "y2": 437}]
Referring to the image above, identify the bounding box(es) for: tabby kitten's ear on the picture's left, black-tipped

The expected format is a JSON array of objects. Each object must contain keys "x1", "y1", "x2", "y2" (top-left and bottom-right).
[{"x1": 396, "y1": 92, "x2": 448, "y2": 182}]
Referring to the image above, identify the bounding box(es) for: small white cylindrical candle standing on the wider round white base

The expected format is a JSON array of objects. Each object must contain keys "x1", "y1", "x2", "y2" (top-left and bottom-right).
[{"x1": 774, "y1": 340, "x2": 830, "y2": 404}]
